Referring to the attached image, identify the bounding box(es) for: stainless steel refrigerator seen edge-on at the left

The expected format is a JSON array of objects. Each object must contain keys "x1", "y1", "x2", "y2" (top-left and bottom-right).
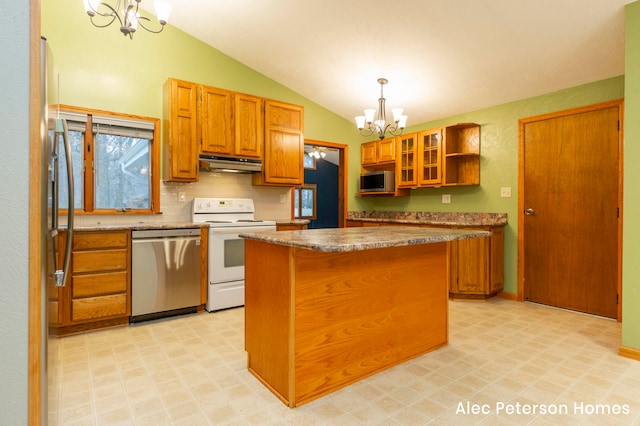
[{"x1": 40, "y1": 38, "x2": 74, "y2": 424}]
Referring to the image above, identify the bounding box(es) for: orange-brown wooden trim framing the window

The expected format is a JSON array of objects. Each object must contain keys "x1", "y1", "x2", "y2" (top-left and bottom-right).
[{"x1": 52, "y1": 105, "x2": 161, "y2": 215}]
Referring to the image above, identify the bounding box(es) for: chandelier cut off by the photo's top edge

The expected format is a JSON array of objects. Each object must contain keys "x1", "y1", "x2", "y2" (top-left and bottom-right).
[{"x1": 83, "y1": 0, "x2": 171, "y2": 39}]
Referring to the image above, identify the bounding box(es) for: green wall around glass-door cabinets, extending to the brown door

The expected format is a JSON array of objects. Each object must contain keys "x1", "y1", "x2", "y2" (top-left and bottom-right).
[{"x1": 358, "y1": 76, "x2": 624, "y2": 293}]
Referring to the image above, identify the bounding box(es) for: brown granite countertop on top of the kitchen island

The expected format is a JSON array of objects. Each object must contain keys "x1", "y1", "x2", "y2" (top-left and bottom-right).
[{"x1": 240, "y1": 226, "x2": 491, "y2": 252}]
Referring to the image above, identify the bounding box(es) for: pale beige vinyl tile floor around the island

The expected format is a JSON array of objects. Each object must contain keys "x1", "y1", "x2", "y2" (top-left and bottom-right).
[{"x1": 49, "y1": 299, "x2": 640, "y2": 426}]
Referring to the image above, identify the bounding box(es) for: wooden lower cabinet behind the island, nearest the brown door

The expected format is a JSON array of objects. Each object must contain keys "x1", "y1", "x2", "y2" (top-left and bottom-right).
[{"x1": 347, "y1": 220, "x2": 504, "y2": 300}]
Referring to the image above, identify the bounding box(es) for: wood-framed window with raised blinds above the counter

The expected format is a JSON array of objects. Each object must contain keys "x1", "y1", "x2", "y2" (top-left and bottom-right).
[{"x1": 52, "y1": 107, "x2": 160, "y2": 214}]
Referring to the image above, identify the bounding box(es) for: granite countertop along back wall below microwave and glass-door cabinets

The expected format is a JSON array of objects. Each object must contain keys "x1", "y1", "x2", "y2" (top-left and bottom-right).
[{"x1": 347, "y1": 211, "x2": 507, "y2": 226}]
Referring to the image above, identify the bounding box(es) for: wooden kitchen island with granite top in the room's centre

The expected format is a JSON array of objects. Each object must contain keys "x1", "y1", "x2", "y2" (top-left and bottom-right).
[{"x1": 240, "y1": 226, "x2": 491, "y2": 407}]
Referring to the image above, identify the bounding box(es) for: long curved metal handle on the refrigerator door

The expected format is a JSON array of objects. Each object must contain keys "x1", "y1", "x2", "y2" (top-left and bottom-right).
[{"x1": 53, "y1": 118, "x2": 75, "y2": 287}]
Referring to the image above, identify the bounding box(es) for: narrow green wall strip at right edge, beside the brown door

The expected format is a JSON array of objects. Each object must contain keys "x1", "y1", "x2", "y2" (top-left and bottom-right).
[{"x1": 622, "y1": 2, "x2": 640, "y2": 349}]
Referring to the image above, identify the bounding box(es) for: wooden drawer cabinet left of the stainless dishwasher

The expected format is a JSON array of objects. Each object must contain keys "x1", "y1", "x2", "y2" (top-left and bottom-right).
[{"x1": 52, "y1": 230, "x2": 131, "y2": 335}]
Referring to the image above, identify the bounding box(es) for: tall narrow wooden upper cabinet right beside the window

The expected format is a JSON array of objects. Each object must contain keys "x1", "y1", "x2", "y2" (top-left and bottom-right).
[{"x1": 163, "y1": 79, "x2": 200, "y2": 182}]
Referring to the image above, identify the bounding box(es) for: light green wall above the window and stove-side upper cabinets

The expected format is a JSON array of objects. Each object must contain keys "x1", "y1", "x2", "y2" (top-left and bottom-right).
[{"x1": 42, "y1": 0, "x2": 357, "y2": 143}]
